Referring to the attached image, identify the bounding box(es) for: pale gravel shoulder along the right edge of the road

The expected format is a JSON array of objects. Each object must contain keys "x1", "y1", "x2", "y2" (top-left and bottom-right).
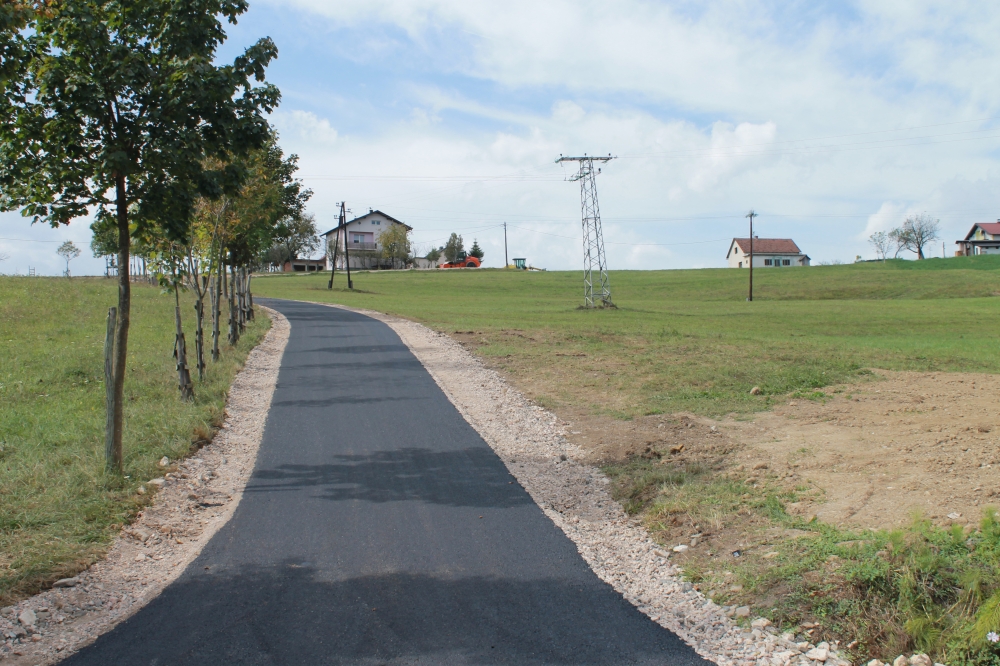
[{"x1": 321, "y1": 304, "x2": 847, "y2": 666}]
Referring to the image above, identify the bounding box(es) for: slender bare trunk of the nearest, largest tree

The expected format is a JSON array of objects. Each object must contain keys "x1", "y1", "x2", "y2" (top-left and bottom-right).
[{"x1": 108, "y1": 175, "x2": 132, "y2": 473}]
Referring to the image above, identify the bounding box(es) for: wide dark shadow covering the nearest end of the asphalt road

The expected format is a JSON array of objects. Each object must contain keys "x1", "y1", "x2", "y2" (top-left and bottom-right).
[{"x1": 65, "y1": 562, "x2": 708, "y2": 666}]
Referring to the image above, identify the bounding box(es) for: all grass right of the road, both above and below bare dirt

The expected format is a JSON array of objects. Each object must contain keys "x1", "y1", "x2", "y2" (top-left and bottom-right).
[{"x1": 256, "y1": 257, "x2": 1000, "y2": 666}]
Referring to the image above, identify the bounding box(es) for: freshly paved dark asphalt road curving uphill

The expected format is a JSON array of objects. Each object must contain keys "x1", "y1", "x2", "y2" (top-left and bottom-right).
[{"x1": 64, "y1": 301, "x2": 709, "y2": 666}]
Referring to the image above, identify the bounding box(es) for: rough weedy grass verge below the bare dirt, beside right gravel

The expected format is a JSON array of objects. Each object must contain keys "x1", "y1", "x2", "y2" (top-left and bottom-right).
[{"x1": 604, "y1": 459, "x2": 1000, "y2": 665}]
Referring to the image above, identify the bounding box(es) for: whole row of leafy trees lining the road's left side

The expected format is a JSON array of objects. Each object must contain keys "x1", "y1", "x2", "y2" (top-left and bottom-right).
[{"x1": 0, "y1": 0, "x2": 296, "y2": 471}]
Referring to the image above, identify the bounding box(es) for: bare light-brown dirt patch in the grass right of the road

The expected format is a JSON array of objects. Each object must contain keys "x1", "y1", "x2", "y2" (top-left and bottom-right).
[{"x1": 720, "y1": 371, "x2": 1000, "y2": 528}]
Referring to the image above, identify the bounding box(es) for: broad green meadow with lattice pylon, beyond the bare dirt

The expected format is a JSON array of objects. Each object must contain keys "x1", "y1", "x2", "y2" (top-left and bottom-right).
[{"x1": 255, "y1": 256, "x2": 1000, "y2": 418}]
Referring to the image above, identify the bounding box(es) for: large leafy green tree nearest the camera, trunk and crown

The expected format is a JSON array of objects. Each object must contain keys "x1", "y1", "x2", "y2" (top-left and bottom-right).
[{"x1": 0, "y1": 0, "x2": 280, "y2": 470}]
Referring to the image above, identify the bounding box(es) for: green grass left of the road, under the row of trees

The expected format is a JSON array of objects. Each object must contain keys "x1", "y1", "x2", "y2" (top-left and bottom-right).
[{"x1": 0, "y1": 277, "x2": 270, "y2": 605}]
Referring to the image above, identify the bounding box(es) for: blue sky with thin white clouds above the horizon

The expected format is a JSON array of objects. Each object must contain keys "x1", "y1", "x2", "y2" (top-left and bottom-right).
[{"x1": 0, "y1": 0, "x2": 1000, "y2": 274}]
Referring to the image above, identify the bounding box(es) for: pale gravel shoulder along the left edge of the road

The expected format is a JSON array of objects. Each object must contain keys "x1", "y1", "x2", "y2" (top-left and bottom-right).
[{"x1": 0, "y1": 308, "x2": 290, "y2": 666}]
